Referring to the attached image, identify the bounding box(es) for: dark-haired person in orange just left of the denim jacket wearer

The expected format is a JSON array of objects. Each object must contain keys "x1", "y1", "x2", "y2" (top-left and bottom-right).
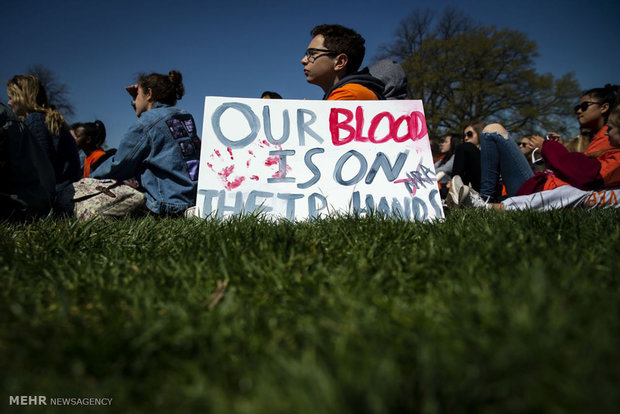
[{"x1": 71, "y1": 120, "x2": 116, "y2": 178}]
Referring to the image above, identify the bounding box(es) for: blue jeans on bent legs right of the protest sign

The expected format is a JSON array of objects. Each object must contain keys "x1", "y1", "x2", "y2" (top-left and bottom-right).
[{"x1": 480, "y1": 132, "x2": 534, "y2": 201}]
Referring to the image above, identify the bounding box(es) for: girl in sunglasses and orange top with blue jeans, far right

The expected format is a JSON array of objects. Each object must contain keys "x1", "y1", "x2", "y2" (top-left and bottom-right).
[{"x1": 456, "y1": 85, "x2": 620, "y2": 205}]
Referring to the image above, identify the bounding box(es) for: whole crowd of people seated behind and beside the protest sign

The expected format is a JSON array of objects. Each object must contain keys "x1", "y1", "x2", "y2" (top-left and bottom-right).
[{"x1": 0, "y1": 21, "x2": 620, "y2": 218}]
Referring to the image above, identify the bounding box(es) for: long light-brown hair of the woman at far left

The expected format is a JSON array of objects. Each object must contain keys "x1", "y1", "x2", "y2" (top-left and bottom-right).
[{"x1": 6, "y1": 75, "x2": 67, "y2": 135}]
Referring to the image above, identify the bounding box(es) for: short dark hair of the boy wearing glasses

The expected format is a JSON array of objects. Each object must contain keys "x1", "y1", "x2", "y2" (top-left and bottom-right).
[{"x1": 310, "y1": 24, "x2": 366, "y2": 75}]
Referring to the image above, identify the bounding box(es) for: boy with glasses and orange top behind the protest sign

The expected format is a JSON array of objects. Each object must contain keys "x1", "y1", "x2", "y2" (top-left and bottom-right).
[{"x1": 301, "y1": 24, "x2": 385, "y2": 100}]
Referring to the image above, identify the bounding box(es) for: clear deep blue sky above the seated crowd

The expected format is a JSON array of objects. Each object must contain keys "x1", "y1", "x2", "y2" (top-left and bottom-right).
[{"x1": 0, "y1": 0, "x2": 620, "y2": 147}]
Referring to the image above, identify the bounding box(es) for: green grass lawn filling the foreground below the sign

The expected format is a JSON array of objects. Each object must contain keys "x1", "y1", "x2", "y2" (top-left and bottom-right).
[{"x1": 0, "y1": 210, "x2": 620, "y2": 413}]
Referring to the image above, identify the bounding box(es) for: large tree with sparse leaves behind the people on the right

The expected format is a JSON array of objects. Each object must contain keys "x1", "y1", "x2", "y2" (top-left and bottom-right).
[{"x1": 381, "y1": 9, "x2": 580, "y2": 137}]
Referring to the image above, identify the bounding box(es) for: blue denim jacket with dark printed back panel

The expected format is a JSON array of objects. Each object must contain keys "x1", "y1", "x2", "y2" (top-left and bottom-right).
[{"x1": 91, "y1": 102, "x2": 200, "y2": 214}]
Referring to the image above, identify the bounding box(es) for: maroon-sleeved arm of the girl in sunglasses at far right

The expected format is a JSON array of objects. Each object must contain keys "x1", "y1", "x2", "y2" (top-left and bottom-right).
[{"x1": 542, "y1": 140, "x2": 603, "y2": 190}]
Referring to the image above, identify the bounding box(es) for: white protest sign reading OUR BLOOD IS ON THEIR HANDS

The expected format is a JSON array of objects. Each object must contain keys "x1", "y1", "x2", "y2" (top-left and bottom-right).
[{"x1": 196, "y1": 97, "x2": 444, "y2": 220}]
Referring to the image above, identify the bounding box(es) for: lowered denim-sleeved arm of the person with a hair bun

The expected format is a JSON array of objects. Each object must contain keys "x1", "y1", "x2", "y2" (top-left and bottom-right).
[{"x1": 90, "y1": 124, "x2": 150, "y2": 180}]
